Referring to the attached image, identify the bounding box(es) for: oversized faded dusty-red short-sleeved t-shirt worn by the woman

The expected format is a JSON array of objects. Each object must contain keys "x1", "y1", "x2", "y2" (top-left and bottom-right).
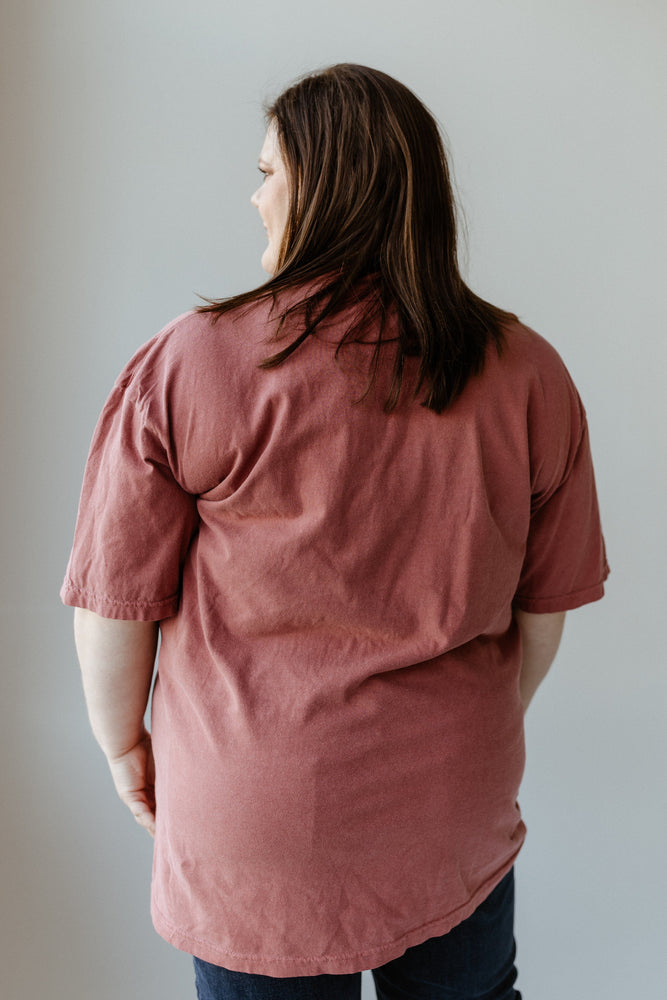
[{"x1": 62, "y1": 292, "x2": 608, "y2": 976}]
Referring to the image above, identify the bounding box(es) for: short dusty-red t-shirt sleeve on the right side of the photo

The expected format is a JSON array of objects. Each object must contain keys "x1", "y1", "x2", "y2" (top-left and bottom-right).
[{"x1": 513, "y1": 366, "x2": 609, "y2": 614}]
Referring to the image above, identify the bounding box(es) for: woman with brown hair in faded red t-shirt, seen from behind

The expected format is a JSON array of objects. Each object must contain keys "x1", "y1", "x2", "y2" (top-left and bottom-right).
[{"x1": 62, "y1": 65, "x2": 608, "y2": 1000}]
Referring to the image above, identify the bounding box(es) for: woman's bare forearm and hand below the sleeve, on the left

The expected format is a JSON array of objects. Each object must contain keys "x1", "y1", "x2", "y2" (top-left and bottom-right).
[{"x1": 74, "y1": 608, "x2": 158, "y2": 836}]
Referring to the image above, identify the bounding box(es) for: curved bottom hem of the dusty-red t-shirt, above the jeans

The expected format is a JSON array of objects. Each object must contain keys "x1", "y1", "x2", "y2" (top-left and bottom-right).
[{"x1": 151, "y1": 852, "x2": 518, "y2": 978}]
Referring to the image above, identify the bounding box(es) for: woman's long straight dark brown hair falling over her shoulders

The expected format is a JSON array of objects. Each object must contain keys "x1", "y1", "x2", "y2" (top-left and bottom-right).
[{"x1": 197, "y1": 63, "x2": 517, "y2": 413}]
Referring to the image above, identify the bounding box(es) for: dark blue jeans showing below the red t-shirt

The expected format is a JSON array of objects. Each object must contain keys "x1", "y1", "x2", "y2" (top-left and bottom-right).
[{"x1": 194, "y1": 871, "x2": 521, "y2": 1000}]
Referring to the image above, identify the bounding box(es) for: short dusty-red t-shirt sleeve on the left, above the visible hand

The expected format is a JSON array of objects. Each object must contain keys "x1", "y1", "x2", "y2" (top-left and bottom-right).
[{"x1": 60, "y1": 369, "x2": 198, "y2": 621}]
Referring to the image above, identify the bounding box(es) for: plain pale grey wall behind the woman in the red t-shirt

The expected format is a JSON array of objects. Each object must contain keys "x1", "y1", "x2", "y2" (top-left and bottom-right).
[{"x1": 0, "y1": 0, "x2": 667, "y2": 1000}]
